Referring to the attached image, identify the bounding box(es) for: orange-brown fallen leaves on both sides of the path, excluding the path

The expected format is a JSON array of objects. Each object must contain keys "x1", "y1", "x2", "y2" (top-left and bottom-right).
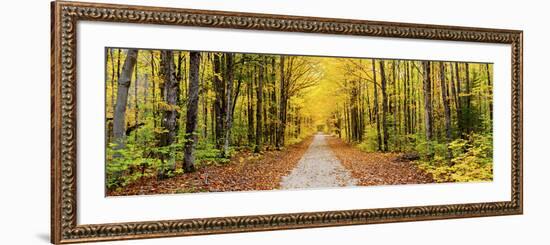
[{"x1": 108, "y1": 133, "x2": 435, "y2": 196}]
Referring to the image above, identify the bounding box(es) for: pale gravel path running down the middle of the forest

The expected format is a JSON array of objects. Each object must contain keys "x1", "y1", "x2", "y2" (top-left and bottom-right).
[{"x1": 280, "y1": 134, "x2": 357, "y2": 189}]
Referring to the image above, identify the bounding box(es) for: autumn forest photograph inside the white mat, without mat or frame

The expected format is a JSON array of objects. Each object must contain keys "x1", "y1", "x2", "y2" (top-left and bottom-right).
[{"x1": 105, "y1": 47, "x2": 494, "y2": 196}]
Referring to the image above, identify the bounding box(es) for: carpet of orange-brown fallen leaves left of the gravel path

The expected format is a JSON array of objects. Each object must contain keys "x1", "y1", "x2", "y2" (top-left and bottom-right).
[{"x1": 107, "y1": 137, "x2": 313, "y2": 196}]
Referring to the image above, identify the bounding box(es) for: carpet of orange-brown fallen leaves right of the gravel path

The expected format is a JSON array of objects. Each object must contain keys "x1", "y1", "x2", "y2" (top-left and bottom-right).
[{"x1": 327, "y1": 137, "x2": 435, "y2": 186}]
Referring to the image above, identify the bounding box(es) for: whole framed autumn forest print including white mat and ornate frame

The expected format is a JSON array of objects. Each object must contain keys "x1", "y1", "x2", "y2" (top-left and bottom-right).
[{"x1": 51, "y1": 1, "x2": 523, "y2": 243}]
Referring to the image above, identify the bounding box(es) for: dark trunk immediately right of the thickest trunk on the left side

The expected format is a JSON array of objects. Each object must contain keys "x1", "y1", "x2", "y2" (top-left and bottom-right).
[{"x1": 183, "y1": 52, "x2": 200, "y2": 172}]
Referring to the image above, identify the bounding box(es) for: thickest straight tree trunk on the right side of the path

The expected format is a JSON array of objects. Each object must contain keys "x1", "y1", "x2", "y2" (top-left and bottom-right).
[{"x1": 422, "y1": 61, "x2": 434, "y2": 159}]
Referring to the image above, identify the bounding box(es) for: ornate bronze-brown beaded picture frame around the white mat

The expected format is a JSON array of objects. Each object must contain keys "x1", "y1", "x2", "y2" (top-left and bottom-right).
[{"x1": 51, "y1": 1, "x2": 523, "y2": 244}]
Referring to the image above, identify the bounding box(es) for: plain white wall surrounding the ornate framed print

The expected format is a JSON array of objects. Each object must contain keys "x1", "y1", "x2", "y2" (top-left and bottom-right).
[{"x1": 0, "y1": 0, "x2": 550, "y2": 245}]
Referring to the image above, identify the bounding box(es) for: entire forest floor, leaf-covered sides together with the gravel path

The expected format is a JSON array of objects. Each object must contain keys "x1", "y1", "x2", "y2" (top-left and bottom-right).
[{"x1": 108, "y1": 134, "x2": 435, "y2": 196}]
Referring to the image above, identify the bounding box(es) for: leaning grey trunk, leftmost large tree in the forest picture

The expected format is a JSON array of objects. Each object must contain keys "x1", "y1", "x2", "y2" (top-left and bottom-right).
[{"x1": 113, "y1": 49, "x2": 138, "y2": 151}]
